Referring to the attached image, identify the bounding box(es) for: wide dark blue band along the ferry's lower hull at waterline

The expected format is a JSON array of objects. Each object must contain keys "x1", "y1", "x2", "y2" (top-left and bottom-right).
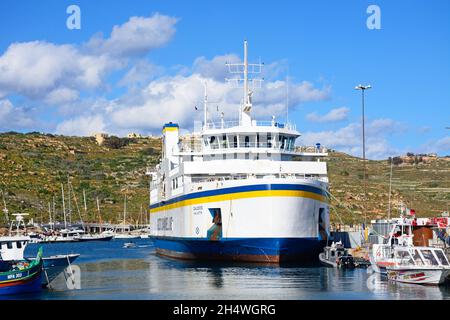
[{"x1": 153, "y1": 237, "x2": 325, "y2": 263}]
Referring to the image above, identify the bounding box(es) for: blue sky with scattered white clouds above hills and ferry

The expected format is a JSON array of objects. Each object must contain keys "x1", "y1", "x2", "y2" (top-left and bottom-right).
[{"x1": 0, "y1": 0, "x2": 450, "y2": 159}]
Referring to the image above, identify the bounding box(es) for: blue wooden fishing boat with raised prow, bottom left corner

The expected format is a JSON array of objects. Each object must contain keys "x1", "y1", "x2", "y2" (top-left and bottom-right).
[{"x1": 0, "y1": 248, "x2": 43, "y2": 295}]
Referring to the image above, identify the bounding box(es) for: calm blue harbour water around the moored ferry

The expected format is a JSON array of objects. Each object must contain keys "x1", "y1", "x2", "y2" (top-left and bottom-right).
[{"x1": 15, "y1": 239, "x2": 450, "y2": 300}]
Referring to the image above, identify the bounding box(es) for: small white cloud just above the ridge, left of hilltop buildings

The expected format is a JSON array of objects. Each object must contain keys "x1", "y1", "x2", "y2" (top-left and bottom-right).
[{"x1": 56, "y1": 115, "x2": 105, "y2": 136}]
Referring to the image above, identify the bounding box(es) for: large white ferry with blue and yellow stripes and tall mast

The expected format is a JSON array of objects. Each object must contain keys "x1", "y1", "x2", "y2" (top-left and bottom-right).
[{"x1": 148, "y1": 41, "x2": 329, "y2": 263}]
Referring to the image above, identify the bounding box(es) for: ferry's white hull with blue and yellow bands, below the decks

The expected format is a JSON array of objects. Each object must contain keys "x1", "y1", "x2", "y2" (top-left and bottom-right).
[{"x1": 150, "y1": 181, "x2": 329, "y2": 263}]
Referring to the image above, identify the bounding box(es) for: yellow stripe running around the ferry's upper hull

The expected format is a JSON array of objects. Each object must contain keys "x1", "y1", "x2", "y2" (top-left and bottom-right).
[{"x1": 150, "y1": 190, "x2": 328, "y2": 214}]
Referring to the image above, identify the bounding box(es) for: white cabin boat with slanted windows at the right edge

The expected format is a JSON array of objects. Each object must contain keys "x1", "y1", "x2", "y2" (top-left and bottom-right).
[{"x1": 386, "y1": 247, "x2": 450, "y2": 285}]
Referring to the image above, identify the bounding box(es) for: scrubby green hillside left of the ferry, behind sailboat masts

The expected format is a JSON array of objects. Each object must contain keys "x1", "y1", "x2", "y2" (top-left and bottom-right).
[{"x1": 0, "y1": 133, "x2": 161, "y2": 222}]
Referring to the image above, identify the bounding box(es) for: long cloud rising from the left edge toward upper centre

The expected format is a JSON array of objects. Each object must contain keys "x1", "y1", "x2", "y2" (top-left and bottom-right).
[{"x1": 0, "y1": 13, "x2": 177, "y2": 104}]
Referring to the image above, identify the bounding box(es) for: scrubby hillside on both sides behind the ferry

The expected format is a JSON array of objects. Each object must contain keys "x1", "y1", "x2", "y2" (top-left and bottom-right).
[{"x1": 0, "y1": 133, "x2": 450, "y2": 223}]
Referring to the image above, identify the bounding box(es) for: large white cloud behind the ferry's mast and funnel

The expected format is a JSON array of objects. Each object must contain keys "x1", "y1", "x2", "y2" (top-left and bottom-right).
[{"x1": 104, "y1": 63, "x2": 329, "y2": 132}]
